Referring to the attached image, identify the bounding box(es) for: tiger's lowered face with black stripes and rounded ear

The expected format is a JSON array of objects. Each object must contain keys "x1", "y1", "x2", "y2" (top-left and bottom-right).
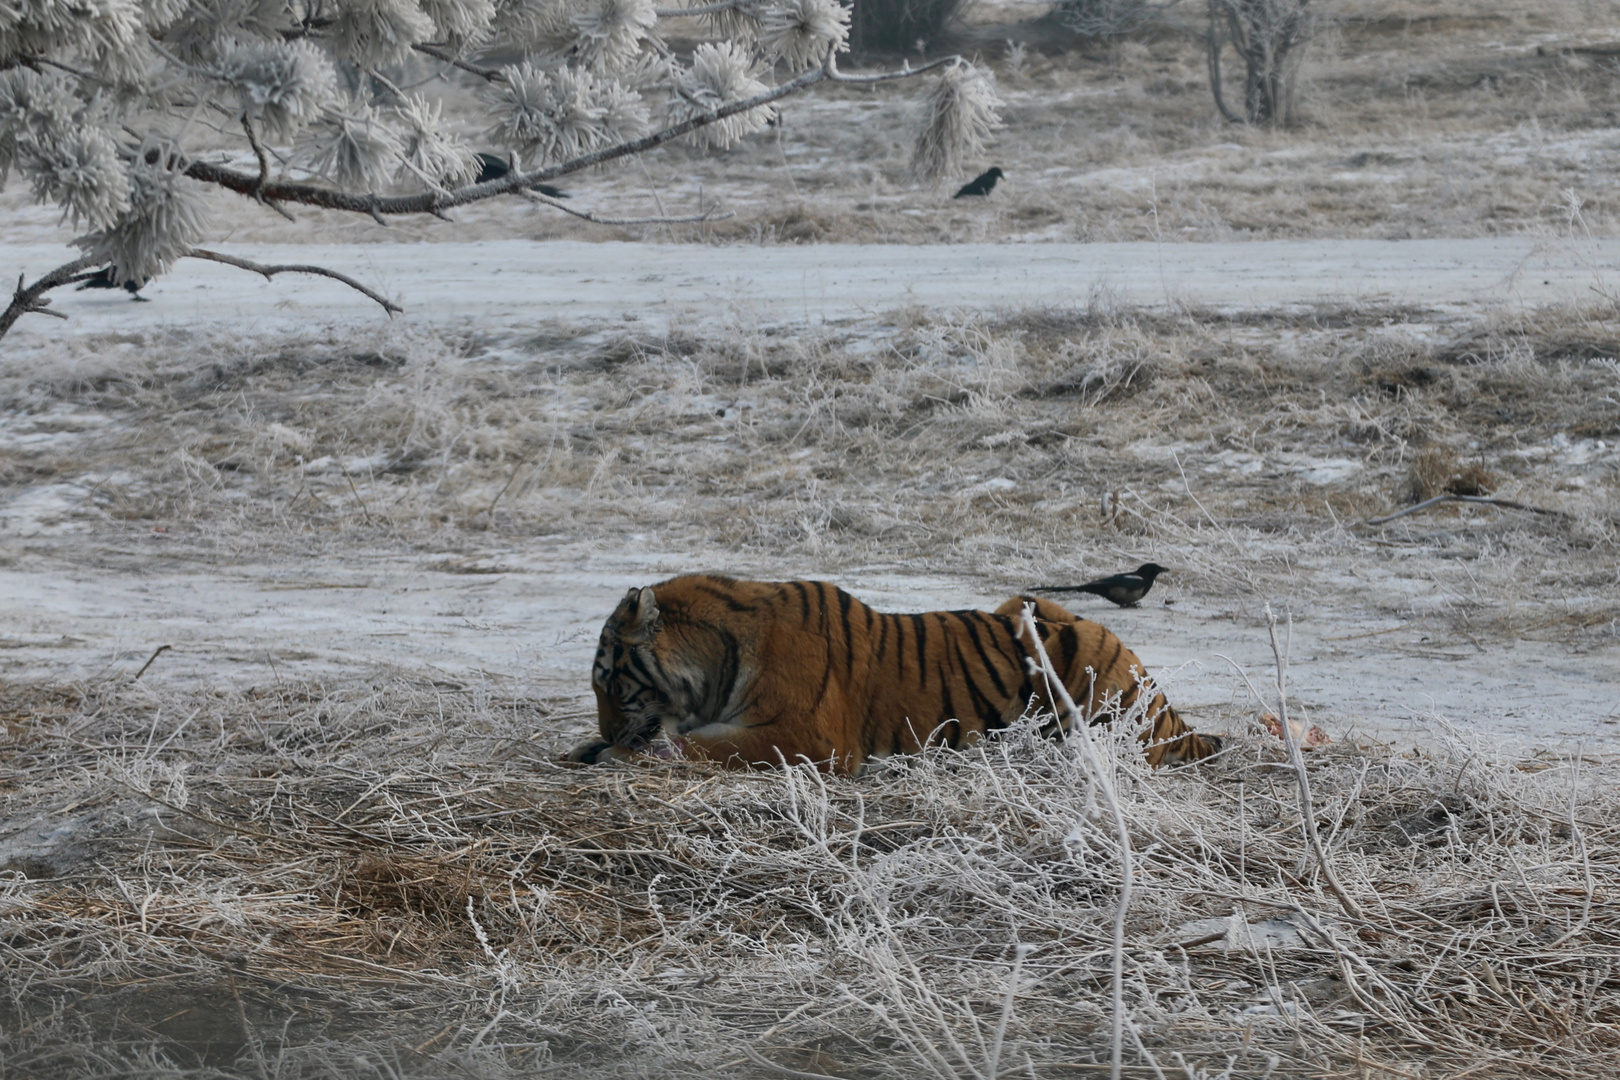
[{"x1": 591, "y1": 588, "x2": 672, "y2": 753}]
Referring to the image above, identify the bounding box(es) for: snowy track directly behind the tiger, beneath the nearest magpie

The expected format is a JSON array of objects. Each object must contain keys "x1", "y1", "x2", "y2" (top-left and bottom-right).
[{"x1": 0, "y1": 538, "x2": 1620, "y2": 751}]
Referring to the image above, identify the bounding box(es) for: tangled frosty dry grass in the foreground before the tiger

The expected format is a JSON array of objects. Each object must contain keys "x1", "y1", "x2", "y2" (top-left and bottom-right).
[{"x1": 0, "y1": 670, "x2": 1620, "y2": 1078}]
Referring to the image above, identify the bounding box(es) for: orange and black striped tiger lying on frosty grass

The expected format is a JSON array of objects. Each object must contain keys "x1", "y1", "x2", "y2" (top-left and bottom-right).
[{"x1": 569, "y1": 575, "x2": 1220, "y2": 772}]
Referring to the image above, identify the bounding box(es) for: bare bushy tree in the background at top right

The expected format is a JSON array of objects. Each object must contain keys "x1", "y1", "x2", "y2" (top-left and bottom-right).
[{"x1": 1209, "y1": 0, "x2": 1312, "y2": 126}]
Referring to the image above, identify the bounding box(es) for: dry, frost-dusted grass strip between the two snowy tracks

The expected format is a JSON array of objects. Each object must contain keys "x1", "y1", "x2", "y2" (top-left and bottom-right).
[{"x1": 0, "y1": 300, "x2": 1620, "y2": 644}]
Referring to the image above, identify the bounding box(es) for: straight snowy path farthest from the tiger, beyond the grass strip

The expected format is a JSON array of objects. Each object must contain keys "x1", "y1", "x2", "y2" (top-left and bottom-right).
[{"x1": 0, "y1": 236, "x2": 1620, "y2": 335}]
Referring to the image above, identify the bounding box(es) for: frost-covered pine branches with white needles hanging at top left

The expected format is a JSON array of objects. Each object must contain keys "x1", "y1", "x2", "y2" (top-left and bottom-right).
[{"x1": 0, "y1": 0, "x2": 1000, "y2": 337}]
